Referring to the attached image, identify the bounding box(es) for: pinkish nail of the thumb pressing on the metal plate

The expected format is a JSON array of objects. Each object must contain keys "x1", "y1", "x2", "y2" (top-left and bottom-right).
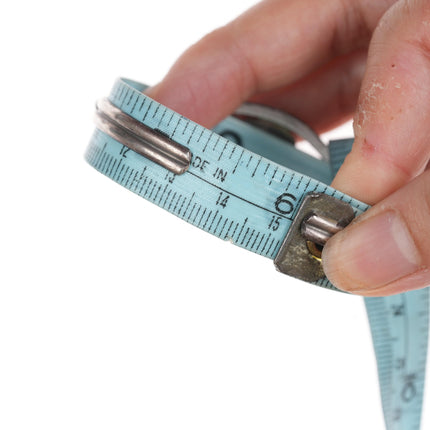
[{"x1": 322, "y1": 211, "x2": 421, "y2": 294}]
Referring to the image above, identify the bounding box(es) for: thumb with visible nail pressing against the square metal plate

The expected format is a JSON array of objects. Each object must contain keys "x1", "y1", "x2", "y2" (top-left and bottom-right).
[{"x1": 322, "y1": 171, "x2": 430, "y2": 296}]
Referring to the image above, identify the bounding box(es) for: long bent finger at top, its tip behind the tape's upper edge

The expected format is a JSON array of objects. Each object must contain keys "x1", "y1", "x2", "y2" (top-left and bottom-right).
[{"x1": 148, "y1": 0, "x2": 394, "y2": 127}]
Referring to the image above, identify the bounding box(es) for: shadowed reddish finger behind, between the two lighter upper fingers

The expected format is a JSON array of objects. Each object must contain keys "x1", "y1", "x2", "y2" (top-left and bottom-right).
[{"x1": 250, "y1": 50, "x2": 367, "y2": 133}]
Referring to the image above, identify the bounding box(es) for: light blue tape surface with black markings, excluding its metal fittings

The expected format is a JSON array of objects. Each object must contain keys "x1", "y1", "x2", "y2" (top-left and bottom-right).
[{"x1": 86, "y1": 79, "x2": 429, "y2": 430}]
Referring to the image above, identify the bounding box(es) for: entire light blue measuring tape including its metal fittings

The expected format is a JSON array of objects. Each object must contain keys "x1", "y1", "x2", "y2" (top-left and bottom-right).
[{"x1": 86, "y1": 79, "x2": 429, "y2": 430}]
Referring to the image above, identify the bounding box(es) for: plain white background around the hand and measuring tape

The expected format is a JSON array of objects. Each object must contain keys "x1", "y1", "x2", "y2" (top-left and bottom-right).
[{"x1": 0, "y1": 0, "x2": 430, "y2": 430}]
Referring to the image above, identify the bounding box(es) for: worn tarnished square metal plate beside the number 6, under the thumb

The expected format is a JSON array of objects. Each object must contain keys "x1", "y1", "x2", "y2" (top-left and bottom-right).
[{"x1": 274, "y1": 193, "x2": 354, "y2": 282}]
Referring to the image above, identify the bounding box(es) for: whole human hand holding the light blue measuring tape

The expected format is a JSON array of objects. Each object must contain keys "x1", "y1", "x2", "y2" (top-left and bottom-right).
[{"x1": 148, "y1": 0, "x2": 430, "y2": 296}]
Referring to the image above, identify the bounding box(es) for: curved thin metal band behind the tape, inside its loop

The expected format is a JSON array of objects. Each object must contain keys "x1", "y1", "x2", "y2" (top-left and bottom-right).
[{"x1": 233, "y1": 103, "x2": 329, "y2": 161}]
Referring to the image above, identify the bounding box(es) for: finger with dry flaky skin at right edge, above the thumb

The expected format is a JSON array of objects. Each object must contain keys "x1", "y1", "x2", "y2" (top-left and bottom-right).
[{"x1": 333, "y1": 0, "x2": 430, "y2": 204}]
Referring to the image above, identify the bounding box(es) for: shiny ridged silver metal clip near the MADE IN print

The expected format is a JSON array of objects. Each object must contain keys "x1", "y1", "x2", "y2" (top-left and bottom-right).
[{"x1": 95, "y1": 98, "x2": 191, "y2": 175}]
